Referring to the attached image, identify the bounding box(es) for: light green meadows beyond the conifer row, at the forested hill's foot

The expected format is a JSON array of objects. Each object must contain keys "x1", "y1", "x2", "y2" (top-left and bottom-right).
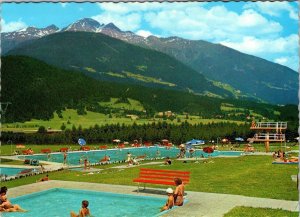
[{"x1": 2, "y1": 108, "x2": 244, "y2": 131}]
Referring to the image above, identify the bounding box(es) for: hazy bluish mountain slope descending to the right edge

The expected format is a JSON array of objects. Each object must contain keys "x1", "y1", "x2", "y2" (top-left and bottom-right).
[{"x1": 137, "y1": 36, "x2": 299, "y2": 104}]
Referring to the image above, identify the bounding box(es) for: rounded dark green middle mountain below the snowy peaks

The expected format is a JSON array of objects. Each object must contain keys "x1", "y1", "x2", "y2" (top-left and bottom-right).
[{"x1": 8, "y1": 32, "x2": 232, "y2": 97}]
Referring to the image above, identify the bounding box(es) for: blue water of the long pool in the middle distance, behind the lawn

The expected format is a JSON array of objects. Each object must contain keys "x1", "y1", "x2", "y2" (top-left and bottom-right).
[{"x1": 20, "y1": 146, "x2": 242, "y2": 165}]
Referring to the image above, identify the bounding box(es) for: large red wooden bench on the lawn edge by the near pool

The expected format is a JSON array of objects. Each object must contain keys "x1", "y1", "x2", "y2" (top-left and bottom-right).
[{"x1": 133, "y1": 168, "x2": 190, "y2": 191}]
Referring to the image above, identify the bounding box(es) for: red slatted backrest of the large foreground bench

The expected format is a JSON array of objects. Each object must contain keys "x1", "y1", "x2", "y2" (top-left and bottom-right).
[{"x1": 139, "y1": 168, "x2": 190, "y2": 184}]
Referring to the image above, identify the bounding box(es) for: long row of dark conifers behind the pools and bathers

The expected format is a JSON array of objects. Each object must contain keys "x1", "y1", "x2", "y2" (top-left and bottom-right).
[{"x1": 2, "y1": 122, "x2": 298, "y2": 144}]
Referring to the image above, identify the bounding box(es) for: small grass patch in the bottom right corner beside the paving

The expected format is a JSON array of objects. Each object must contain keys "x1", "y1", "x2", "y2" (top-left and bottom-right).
[{"x1": 224, "y1": 206, "x2": 299, "y2": 217}]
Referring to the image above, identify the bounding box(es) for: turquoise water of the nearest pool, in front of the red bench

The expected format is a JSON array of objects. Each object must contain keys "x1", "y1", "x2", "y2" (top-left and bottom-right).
[{"x1": 3, "y1": 188, "x2": 166, "y2": 217}]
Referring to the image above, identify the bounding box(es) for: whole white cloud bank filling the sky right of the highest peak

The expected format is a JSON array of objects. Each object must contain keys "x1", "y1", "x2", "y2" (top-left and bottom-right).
[{"x1": 93, "y1": 2, "x2": 298, "y2": 69}]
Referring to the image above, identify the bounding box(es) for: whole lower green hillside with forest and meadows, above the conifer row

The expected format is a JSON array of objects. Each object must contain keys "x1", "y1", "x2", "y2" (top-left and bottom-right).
[{"x1": 1, "y1": 56, "x2": 298, "y2": 130}]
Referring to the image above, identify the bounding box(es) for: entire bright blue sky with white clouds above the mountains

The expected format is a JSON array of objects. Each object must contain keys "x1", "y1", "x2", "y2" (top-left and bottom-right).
[{"x1": 1, "y1": 2, "x2": 299, "y2": 71}]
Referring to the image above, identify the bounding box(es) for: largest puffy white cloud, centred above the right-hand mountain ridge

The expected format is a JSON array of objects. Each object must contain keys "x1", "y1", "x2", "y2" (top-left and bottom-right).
[{"x1": 144, "y1": 6, "x2": 282, "y2": 41}]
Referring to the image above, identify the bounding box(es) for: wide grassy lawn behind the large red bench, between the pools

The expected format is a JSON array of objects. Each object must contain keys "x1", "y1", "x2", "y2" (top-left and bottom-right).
[{"x1": 3, "y1": 156, "x2": 298, "y2": 201}]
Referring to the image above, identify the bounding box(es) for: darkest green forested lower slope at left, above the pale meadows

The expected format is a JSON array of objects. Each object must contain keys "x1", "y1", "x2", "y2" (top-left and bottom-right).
[{"x1": 2, "y1": 56, "x2": 221, "y2": 122}]
